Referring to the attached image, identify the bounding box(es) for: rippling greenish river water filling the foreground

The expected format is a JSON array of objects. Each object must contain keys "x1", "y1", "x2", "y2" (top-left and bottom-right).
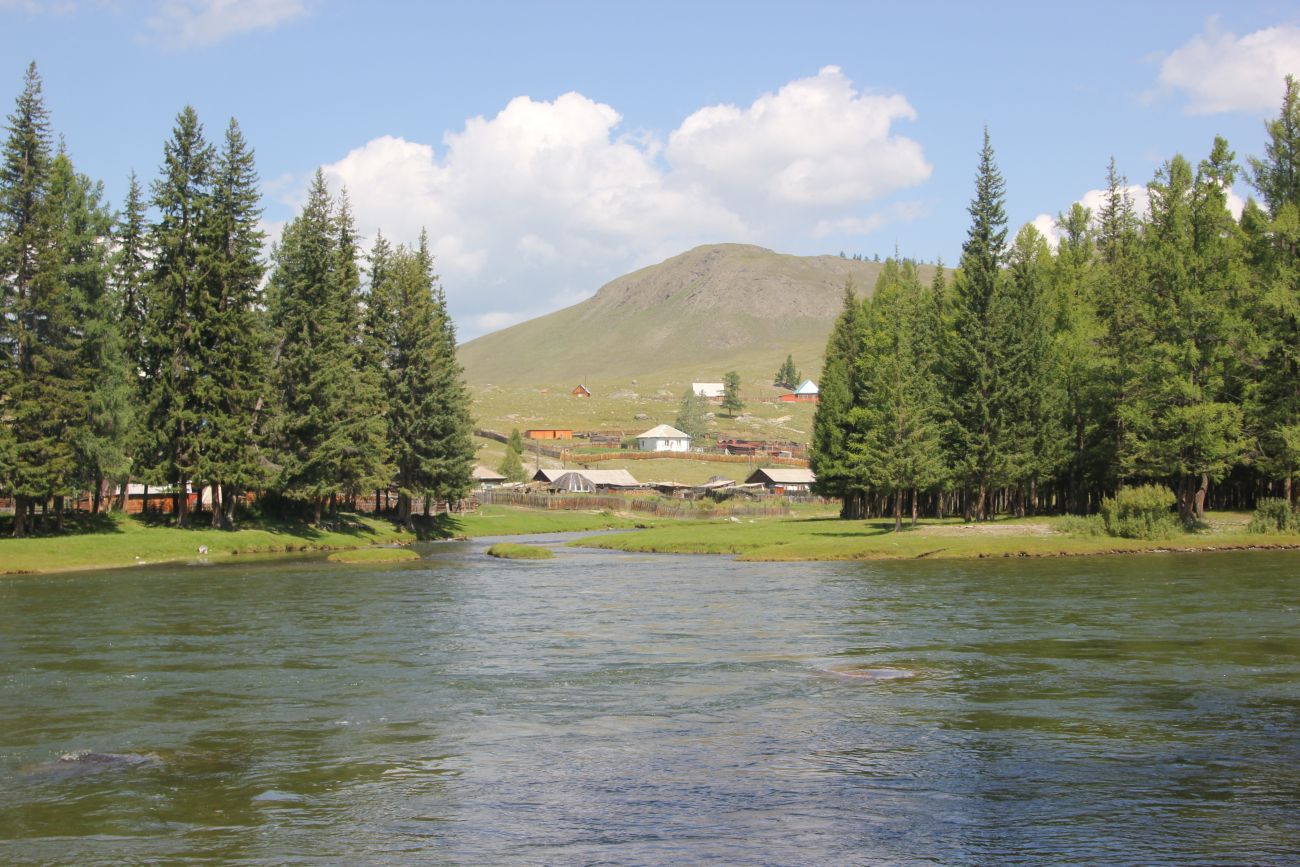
[{"x1": 0, "y1": 541, "x2": 1300, "y2": 864}]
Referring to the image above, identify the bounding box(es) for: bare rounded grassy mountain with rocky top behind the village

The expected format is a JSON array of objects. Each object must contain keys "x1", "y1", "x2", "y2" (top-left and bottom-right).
[{"x1": 459, "y1": 244, "x2": 932, "y2": 387}]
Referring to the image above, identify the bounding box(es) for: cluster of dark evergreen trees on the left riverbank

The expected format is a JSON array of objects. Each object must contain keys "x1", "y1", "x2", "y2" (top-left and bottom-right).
[{"x1": 0, "y1": 64, "x2": 473, "y2": 537}]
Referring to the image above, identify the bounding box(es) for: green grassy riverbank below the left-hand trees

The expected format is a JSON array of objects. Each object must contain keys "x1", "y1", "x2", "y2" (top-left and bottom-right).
[{"x1": 0, "y1": 506, "x2": 638, "y2": 575}]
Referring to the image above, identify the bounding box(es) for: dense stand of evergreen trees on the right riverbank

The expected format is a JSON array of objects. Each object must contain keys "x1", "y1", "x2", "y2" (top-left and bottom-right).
[{"x1": 813, "y1": 78, "x2": 1300, "y2": 526}]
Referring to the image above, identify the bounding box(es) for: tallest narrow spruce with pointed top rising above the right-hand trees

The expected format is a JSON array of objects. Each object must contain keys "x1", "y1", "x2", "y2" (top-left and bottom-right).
[{"x1": 946, "y1": 129, "x2": 1006, "y2": 521}]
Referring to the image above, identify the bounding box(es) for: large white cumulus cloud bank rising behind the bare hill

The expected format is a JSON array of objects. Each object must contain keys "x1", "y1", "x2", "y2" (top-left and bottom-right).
[{"x1": 309, "y1": 66, "x2": 931, "y2": 337}]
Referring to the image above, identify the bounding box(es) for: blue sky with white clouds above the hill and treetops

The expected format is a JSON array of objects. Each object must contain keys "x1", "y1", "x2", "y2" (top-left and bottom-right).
[{"x1": 0, "y1": 0, "x2": 1300, "y2": 337}]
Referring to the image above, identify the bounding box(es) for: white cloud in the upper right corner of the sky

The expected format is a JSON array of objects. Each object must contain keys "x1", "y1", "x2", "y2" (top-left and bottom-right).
[{"x1": 1160, "y1": 18, "x2": 1300, "y2": 114}]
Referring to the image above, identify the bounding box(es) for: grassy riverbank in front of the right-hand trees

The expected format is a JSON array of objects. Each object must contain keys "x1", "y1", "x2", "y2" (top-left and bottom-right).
[{"x1": 572, "y1": 513, "x2": 1300, "y2": 560}]
